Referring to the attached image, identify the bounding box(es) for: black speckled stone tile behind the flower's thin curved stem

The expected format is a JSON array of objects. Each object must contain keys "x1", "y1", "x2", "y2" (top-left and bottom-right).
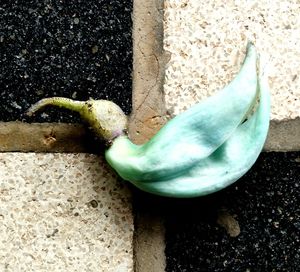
[{"x1": 0, "y1": 0, "x2": 132, "y2": 122}]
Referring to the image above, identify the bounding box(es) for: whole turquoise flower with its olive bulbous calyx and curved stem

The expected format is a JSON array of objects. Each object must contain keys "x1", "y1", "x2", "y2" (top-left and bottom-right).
[{"x1": 29, "y1": 44, "x2": 270, "y2": 198}]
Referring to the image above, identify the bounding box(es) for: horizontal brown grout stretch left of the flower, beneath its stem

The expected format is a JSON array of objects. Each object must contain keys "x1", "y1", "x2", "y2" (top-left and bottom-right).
[{"x1": 0, "y1": 122, "x2": 87, "y2": 152}]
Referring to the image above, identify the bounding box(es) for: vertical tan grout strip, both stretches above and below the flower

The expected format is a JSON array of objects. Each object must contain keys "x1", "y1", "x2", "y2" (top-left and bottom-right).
[{"x1": 129, "y1": 0, "x2": 167, "y2": 272}]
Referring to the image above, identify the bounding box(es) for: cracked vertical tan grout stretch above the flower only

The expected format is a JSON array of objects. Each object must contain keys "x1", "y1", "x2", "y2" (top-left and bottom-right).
[{"x1": 129, "y1": 0, "x2": 168, "y2": 143}]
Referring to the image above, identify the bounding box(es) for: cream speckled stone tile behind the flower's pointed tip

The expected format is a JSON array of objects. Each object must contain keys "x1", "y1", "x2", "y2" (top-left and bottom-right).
[{"x1": 164, "y1": 0, "x2": 300, "y2": 120}]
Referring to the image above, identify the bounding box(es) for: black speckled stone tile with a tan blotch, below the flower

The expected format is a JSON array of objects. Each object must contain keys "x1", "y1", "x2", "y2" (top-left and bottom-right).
[{"x1": 165, "y1": 153, "x2": 300, "y2": 272}]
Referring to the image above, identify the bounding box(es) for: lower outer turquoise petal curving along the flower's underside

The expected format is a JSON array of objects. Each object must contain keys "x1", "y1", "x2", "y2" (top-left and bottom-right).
[{"x1": 120, "y1": 66, "x2": 270, "y2": 198}]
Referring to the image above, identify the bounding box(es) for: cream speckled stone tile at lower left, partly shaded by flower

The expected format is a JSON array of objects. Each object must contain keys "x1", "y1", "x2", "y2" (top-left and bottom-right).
[{"x1": 0, "y1": 153, "x2": 133, "y2": 272}]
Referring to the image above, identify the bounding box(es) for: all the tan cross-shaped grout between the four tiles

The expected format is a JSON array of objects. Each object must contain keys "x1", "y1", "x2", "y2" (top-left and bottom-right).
[{"x1": 0, "y1": 0, "x2": 300, "y2": 272}]
